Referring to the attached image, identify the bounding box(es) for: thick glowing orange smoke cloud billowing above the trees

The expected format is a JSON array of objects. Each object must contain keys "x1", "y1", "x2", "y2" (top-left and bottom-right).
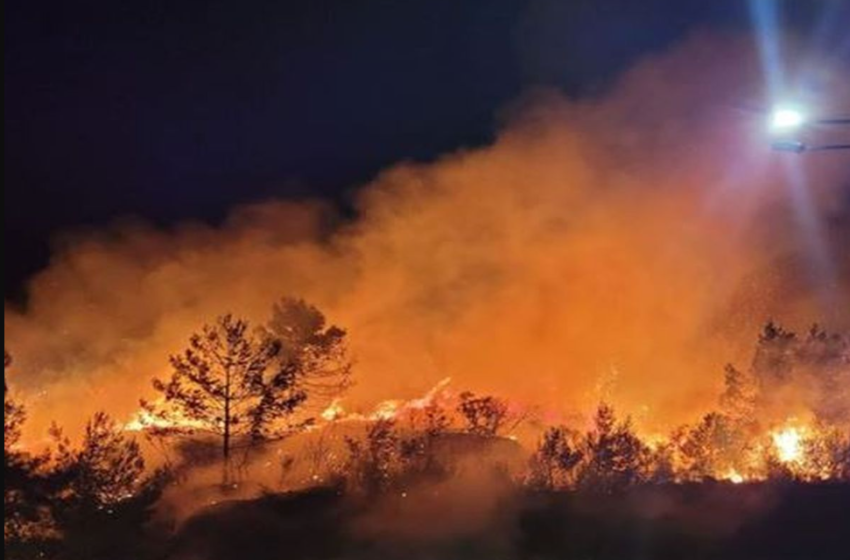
[{"x1": 5, "y1": 32, "x2": 850, "y2": 440}]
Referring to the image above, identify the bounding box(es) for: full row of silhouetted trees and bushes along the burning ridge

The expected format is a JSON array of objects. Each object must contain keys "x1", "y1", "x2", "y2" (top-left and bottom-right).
[{"x1": 4, "y1": 308, "x2": 850, "y2": 560}]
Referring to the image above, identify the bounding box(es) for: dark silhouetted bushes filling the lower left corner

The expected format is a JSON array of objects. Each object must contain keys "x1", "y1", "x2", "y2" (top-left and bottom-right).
[{"x1": 3, "y1": 354, "x2": 169, "y2": 560}]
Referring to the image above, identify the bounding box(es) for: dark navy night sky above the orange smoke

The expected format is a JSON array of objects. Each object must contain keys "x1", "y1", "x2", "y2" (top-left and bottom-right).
[{"x1": 4, "y1": 0, "x2": 840, "y2": 297}]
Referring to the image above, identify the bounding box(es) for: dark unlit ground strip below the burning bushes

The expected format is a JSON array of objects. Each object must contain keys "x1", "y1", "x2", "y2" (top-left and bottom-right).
[{"x1": 167, "y1": 484, "x2": 850, "y2": 560}]
